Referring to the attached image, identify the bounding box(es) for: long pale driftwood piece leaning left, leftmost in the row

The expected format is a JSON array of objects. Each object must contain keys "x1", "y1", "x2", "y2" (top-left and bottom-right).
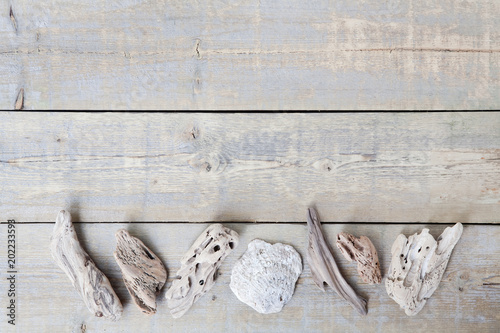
[{"x1": 50, "y1": 210, "x2": 123, "y2": 320}]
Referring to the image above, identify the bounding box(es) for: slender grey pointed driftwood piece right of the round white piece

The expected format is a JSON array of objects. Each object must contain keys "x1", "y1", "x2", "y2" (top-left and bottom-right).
[{"x1": 307, "y1": 208, "x2": 368, "y2": 315}]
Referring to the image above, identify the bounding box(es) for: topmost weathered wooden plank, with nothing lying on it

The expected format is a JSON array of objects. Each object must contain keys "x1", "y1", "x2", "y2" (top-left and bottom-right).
[{"x1": 0, "y1": 0, "x2": 500, "y2": 109}]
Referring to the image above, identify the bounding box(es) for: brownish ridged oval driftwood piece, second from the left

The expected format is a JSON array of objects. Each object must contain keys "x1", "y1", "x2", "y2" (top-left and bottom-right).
[{"x1": 114, "y1": 229, "x2": 167, "y2": 314}]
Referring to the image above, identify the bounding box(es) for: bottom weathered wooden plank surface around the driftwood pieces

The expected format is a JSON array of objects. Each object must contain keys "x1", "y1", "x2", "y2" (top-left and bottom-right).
[{"x1": 0, "y1": 223, "x2": 500, "y2": 333}]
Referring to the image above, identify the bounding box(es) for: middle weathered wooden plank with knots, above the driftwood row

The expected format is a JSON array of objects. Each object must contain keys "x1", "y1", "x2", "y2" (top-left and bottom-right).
[{"x1": 0, "y1": 113, "x2": 500, "y2": 223}]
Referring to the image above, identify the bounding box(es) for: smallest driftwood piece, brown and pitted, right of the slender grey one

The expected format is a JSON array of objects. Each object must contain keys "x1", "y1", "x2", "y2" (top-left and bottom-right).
[{"x1": 337, "y1": 232, "x2": 382, "y2": 284}]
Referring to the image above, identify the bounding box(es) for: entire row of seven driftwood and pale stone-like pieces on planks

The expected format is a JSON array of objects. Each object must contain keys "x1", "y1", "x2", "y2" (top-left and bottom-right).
[{"x1": 51, "y1": 208, "x2": 463, "y2": 320}]
